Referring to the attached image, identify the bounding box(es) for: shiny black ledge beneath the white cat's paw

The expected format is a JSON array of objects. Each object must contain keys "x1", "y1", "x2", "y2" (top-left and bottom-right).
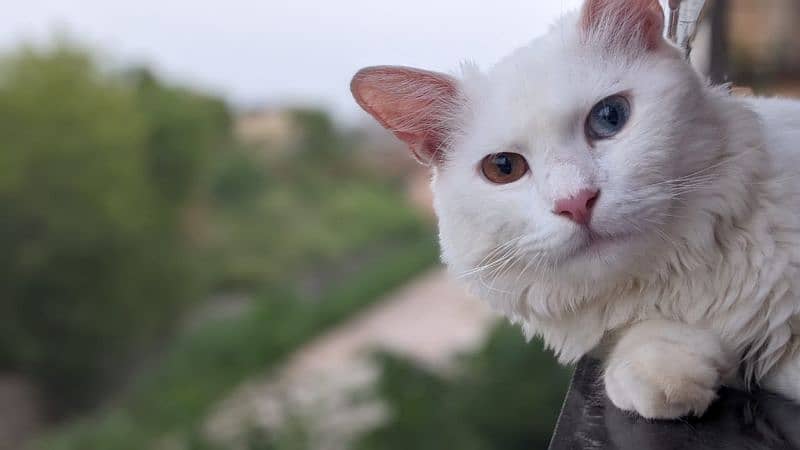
[{"x1": 550, "y1": 359, "x2": 800, "y2": 450}]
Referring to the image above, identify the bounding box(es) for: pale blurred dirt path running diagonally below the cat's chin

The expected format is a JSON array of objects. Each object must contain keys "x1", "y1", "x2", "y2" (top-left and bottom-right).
[{"x1": 207, "y1": 269, "x2": 495, "y2": 450}]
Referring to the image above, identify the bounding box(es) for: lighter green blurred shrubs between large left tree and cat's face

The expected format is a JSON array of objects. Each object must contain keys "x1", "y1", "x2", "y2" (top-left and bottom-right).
[{"x1": 209, "y1": 110, "x2": 432, "y2": 288}]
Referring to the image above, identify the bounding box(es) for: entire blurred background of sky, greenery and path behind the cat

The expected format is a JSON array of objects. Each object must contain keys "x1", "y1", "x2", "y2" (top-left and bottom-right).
[{"x1": 0, "y1": 0, "x2": 800, "y2": 450}]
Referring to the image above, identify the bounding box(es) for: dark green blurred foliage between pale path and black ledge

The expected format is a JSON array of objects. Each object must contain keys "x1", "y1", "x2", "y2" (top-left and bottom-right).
[{"x1": 357, "y1": 325, "x2": 569, "y2": 450}]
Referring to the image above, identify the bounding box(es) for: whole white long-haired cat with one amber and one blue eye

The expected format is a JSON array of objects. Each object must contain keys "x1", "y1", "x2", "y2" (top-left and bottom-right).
[{"x1": 352, "y1": 0, "x2": 800, "y2": 418}]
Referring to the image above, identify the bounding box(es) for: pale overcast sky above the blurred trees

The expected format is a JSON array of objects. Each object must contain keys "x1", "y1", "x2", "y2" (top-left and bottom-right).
[{"x1": 0, "y1": 0, "x2": 581, "y2": 121}]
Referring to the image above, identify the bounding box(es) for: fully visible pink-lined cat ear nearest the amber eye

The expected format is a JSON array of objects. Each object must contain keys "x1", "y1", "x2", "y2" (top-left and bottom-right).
[{"x1": 350, "y1": 66, "x2": 459, "y2": 165}]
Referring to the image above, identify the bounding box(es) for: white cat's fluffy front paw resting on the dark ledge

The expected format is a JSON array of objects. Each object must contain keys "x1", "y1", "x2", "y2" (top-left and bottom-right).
[{"x1": 604, "y1": 320, "x2": 735, "y2": 419}]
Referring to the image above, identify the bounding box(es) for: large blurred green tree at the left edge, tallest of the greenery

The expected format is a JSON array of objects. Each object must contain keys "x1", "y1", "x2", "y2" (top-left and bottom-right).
[{"x1": 0, "y1": 46, "x2": 230, "y2": 411}]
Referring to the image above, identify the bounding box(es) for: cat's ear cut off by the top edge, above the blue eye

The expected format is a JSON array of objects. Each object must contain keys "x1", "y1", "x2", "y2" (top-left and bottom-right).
[{"x1": 580, "y1": 0, "x2": 666, "y2": 50}]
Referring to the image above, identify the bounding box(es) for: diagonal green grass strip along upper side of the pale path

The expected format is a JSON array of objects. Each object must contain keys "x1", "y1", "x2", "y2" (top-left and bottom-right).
[{"x1": 40, "y1": 239, "x2": 437, "y2": 450}]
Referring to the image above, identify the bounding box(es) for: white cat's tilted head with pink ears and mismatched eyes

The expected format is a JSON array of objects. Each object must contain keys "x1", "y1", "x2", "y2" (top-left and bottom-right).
[{"x1": 352, "y1": 0, "x2": 719, "y2": 310}]
